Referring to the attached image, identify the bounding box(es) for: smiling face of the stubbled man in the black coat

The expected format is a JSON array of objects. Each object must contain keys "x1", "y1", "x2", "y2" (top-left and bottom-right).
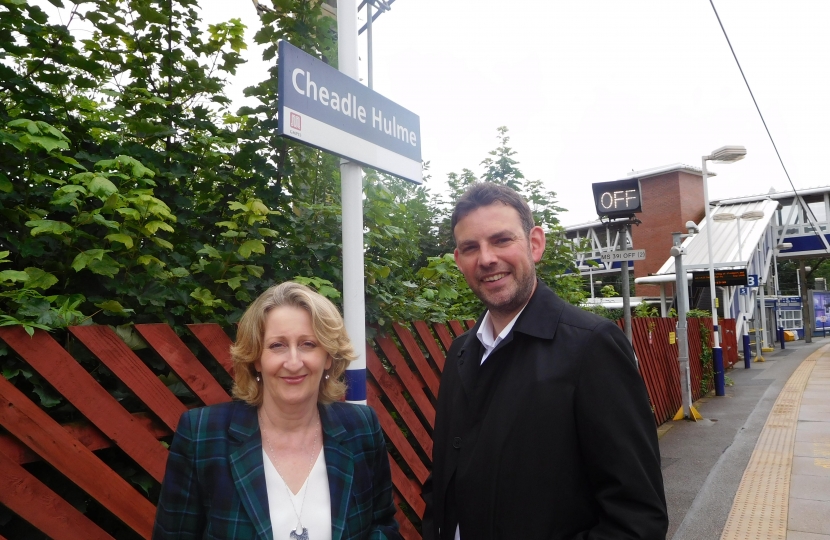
[{"x1": 453, "y1": 202, "x2": 545, "y2": 320}]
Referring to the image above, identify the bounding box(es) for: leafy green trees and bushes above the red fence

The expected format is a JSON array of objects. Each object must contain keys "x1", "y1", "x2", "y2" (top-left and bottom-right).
[{"x1": 0, "y1": 0, "x2": 584, "y2": 338}]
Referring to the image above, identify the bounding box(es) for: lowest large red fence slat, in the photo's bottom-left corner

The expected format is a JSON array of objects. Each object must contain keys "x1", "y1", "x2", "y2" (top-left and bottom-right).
[{"x1": 0, "y1": 453, "x2": 112, "y2": 540}]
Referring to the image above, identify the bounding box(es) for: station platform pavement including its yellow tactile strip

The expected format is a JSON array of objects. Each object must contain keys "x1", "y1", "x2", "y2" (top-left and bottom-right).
[{"x1": 660, "y1": 338, "x2": 830, "y2": 540}]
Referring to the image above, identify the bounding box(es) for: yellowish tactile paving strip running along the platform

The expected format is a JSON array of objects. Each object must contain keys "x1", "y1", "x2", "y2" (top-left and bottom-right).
[{"x1": 721, "y1": 345, "x2": 830, "y2": 540}]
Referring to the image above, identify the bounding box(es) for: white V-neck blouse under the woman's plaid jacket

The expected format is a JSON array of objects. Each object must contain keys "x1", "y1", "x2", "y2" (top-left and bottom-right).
[{"x1": 262, "y1": 448, "x2": 331, "y2": 540}]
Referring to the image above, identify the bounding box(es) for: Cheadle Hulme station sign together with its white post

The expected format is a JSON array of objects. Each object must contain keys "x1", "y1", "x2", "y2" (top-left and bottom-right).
[{"x1": 277, "y1": 5, "x2": 423, "y2": 403}]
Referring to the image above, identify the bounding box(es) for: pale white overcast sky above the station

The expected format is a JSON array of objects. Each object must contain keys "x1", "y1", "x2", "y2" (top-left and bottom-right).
[{"x1": 47, "y1": 0, "x2": 830, "y2": 225}]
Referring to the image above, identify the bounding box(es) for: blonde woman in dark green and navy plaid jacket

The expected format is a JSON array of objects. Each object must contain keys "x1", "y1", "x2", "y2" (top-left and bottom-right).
[{"x1": 158, "y1": 282, "x2": 400, "y2": 540}]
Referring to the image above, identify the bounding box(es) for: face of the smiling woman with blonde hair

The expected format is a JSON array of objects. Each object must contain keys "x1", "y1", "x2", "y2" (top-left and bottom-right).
[{"x1": 254, "y1": 306, "x2": 331, "y2": 406}]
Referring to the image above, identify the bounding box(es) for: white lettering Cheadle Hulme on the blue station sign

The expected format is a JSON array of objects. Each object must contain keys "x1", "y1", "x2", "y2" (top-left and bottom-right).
[{"x1": 291, "y1": 68, "x2": 417, "y2": 146}]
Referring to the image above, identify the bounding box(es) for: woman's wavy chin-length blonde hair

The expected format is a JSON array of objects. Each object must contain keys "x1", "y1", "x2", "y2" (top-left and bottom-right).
[{"x1": 231, "y1": 281, "x2": 357, "y2": 406}]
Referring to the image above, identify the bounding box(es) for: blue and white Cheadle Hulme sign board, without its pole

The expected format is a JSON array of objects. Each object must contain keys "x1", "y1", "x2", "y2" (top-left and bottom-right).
[{"x1": 277, "y1": 40, "x2": 423, "y2": 184}]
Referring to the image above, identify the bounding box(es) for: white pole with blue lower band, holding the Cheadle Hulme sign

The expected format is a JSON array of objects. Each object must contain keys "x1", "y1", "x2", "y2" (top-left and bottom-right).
[{"x1": 337, "y1": 0, "x2": 366, "y2": 404}]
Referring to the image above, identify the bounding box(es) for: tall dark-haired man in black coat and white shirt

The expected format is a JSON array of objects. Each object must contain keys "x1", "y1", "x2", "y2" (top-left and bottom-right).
[{"x1": 423, "y1": 183, "x2": 668, "y2": 540}]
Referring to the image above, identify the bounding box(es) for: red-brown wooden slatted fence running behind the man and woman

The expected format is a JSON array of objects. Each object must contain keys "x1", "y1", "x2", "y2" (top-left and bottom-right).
[{"x1": 0, "y1": 319, "x2": 737, "y2": 540}]
